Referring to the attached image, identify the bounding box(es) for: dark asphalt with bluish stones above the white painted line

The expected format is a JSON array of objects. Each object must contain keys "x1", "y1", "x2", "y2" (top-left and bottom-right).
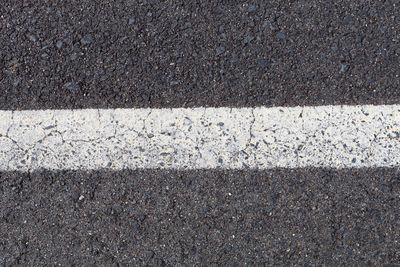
[{"x1": 0, "y1": 0, "x2": 400, "y2": 109}]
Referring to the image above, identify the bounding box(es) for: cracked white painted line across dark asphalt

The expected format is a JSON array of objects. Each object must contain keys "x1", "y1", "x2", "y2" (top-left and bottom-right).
[{"x1": 0, "y1": 105, "x2": 400, "y2": 171}]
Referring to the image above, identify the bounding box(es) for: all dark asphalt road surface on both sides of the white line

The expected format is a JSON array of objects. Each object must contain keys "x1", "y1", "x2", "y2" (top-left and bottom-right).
[{"x1": 0, "y1": 0, "x2": 400, "y2": 266}]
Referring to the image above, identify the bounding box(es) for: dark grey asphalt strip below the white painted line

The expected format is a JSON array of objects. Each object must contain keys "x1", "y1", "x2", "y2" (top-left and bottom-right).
[{"x1": 0, "y1": 169, "x2": 400, "y2": 266}]
